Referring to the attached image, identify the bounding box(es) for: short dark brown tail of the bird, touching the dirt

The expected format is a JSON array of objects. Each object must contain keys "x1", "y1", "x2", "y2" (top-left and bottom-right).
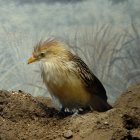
[{"x1": 90, "y1": 95, "x2": 112, "y2": 112}]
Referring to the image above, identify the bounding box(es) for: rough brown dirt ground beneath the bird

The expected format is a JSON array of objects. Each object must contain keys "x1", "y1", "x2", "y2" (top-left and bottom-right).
[{"x1": 0, "y1": 85, "x2": 140, "y2": 140}]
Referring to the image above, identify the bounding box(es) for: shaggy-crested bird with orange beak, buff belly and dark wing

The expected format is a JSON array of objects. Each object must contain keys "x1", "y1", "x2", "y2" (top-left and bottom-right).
[{"x1": 28, "y1": 39, "x2": 112, "y2": 112}]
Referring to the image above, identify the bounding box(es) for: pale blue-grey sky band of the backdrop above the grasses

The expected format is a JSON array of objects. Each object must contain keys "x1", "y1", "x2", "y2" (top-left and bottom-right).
[{"x1": 0, "y1": 0, "x2": 140, "y2": 34}]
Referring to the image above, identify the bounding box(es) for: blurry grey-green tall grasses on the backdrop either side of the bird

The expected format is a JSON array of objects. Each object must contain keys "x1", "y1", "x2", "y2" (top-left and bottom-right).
[{"x1": 0, "y1": 22, "x2": 140, "y2": 102}]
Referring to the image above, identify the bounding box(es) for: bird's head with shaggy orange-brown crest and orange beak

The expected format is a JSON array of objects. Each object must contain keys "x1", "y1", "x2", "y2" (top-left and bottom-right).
[{"x1": 28, "y1": 39, "x2": 69, "y2": 64}]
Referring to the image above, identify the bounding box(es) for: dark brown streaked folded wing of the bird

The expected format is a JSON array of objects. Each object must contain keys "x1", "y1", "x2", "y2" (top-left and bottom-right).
[{"x1": 72, "y1": 56, "x2": 107, "y2": 101}]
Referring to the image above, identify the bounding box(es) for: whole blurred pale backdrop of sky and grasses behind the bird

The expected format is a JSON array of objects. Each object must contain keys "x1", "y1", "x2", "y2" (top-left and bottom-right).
[{"x1": 0, "y1": 0, "x2": 140, "y2": 103}]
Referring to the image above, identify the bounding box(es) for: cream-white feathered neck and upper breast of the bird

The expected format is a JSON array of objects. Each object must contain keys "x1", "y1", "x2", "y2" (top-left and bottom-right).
[{"x1": 42, "y1": 58, "x2": 74, "y2": 86}]
